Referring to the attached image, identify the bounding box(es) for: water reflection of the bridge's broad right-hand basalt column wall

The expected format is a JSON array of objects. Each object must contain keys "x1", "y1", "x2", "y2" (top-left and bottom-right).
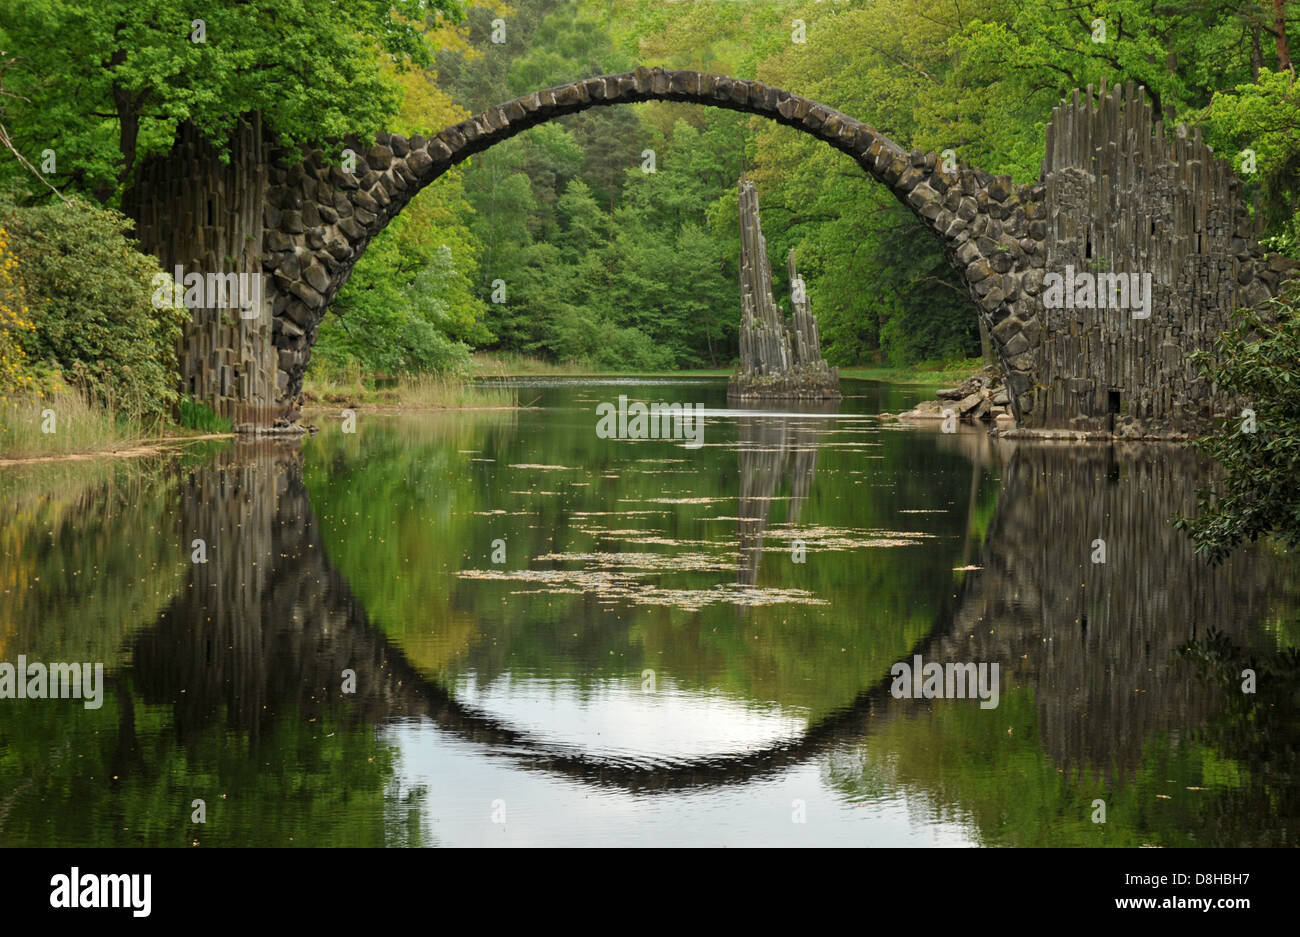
[{"x1": 927, "y1": 443, "x2": 1270, "y2": 773}]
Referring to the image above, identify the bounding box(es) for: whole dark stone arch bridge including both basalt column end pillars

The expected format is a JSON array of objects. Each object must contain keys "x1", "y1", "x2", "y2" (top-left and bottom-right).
[{"x1": 126, "y1": 68, "x2": 1294, "y2": 435}]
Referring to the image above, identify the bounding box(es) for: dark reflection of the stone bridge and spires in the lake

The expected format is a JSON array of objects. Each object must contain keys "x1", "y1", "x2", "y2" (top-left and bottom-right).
[{"x1": 124, "y1": 428, "x2": 1269, "y2": 791}]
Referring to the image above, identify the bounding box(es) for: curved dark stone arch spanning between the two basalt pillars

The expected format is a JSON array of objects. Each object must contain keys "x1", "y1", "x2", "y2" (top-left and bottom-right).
[{"x1": 263, "y1": 68, "x2": 1045, "y2": 417}]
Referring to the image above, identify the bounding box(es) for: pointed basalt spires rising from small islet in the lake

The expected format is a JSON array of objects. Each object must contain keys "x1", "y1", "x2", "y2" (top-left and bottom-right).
[{"x1": 727, "y1": 179, "x2": 840, "y2": 400}]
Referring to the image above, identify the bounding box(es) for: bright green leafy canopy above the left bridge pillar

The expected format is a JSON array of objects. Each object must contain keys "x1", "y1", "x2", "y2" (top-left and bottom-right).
[{"x1": 0, "y1": 0, "x2": 462, "y2": 201}]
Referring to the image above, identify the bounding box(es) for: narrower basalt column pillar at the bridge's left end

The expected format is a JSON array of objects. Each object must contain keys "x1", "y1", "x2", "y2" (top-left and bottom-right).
[{"x1": 124, "y1": 116, "x2": 285, "y2": 430}]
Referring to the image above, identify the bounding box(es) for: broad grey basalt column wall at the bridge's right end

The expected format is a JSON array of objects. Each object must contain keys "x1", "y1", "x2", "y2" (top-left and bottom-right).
[{"x1": 1019, "y1": 83, "x2": 1296, "y2": 437}]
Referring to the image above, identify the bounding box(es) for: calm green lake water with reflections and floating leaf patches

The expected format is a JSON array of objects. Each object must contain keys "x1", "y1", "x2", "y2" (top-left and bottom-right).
[{"x1": 0, "y1": 379, "x2": 1300, "y2": 846}]
